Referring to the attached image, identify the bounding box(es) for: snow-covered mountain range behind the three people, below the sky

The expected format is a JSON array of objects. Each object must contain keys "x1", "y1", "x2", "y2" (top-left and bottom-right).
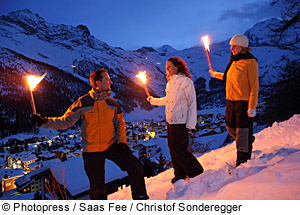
[{"x1": 0, "y1": 10, "x2": 299, "y2": 138}]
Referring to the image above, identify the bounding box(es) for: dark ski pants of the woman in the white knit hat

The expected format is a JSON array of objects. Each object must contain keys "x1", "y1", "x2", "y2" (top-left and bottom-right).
[{"x1": 225, "y1": 100, "x2": 254, "y2": 166}]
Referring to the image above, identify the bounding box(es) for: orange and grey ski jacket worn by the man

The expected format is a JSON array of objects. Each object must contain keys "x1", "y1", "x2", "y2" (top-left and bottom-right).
[{"x1": 42, "y1": 89, "x2": 127, "y2": 152}]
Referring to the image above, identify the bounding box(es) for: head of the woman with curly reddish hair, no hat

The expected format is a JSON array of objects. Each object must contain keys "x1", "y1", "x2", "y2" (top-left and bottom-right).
[{"x1": 166, "y1": 57, "x2": 191, "y2": 78}]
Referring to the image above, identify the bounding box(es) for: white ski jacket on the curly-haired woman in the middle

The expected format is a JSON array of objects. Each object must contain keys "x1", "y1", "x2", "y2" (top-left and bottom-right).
[{"x1": 150, "y1": 73, "x2": 197, "y2": 129}]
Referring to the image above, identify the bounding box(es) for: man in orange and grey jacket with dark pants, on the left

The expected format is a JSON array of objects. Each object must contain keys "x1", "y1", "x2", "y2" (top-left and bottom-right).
[{"x1": 31, "y1": 68, "x2": 149, "y2": 200}]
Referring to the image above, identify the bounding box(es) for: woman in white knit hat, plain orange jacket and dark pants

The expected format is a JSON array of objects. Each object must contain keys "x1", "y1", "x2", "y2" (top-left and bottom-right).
[{"x1": 209, "y1": 34, "x2": 259, "y2": 167}]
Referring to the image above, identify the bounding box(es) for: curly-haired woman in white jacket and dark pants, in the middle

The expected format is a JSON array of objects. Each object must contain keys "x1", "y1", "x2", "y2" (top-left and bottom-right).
[{"x1": 147, "y1": 57, "x2": 203, "y2": 183}]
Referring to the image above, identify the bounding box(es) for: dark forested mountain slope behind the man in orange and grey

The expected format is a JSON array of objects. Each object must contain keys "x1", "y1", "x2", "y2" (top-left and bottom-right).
[{"x1": 0, "y1": 49, "x2": 155, "y2": 138}]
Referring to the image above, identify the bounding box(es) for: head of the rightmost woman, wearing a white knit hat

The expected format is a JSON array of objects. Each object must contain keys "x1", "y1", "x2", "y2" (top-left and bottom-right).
[{"x1": 229, "y1": 34, "x2": 251, "y2": 55}]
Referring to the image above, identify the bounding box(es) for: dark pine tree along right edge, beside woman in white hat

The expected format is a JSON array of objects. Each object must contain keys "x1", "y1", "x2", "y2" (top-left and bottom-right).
[{"x1": 258, "y1": 0, "x2": 300, "y2": 124}]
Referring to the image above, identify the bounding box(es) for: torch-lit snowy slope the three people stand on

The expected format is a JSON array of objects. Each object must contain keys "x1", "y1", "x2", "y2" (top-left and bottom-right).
[{"x1": 108, "y1": 115, "x2": 300, "y2": 200}]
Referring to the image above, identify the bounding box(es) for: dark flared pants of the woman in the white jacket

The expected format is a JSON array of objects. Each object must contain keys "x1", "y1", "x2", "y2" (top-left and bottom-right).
[{"x1": 168, "y1": 124, "x2": 203, "y2": 178}]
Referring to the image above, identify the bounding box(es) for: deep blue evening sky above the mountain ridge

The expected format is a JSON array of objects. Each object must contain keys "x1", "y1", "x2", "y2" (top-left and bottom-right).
[{"x1": 0, "y1": 0, "x2": 279, "y2": 50}]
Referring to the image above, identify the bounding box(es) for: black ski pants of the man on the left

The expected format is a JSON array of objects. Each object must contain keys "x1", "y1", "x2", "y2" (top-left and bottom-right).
[{"x1": 83, "y1": 143, "x2": 149, "y2": 200}]
